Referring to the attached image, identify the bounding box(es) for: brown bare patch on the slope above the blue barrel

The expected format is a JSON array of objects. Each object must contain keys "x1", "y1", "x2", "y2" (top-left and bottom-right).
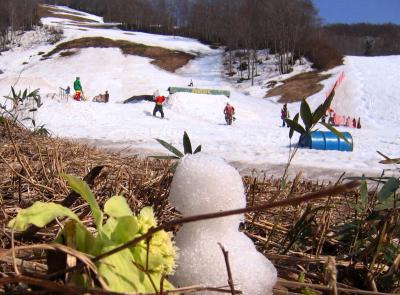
[{"x1": 266, "y1": 72, "x2": 331, "y2": 103}]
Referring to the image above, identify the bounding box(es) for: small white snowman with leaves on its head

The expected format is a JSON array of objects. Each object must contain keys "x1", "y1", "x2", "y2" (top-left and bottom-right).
[{"x1": 170, "y1": 153, "x2": 277, "y2": 295}]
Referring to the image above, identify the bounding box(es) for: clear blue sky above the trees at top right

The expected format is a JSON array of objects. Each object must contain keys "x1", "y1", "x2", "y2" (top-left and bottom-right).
[{"x1": 313, "y1": 0, "x2": 400, "y2": 24}]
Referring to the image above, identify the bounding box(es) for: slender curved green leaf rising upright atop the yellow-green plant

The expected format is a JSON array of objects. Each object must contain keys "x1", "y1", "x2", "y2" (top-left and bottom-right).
[{"x1": 61, "y1": 174, "x2": 103, "y2": 230}]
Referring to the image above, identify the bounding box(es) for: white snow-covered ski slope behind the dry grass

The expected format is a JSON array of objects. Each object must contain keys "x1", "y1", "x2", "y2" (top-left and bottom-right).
[{"x1": 0, "y1": 7, "x2": 400, "y2": 179}]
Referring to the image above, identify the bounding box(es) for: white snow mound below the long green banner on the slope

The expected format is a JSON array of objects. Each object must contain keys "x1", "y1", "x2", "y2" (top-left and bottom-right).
[{"x1": 166, "y1": 92, "x2": 229, "y2": 124}]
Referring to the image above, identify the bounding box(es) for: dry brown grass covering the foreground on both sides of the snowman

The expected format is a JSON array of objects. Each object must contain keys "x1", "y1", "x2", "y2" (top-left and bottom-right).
[{"x1": 0, "y1": 119, "x2": 396, "y2": 294}]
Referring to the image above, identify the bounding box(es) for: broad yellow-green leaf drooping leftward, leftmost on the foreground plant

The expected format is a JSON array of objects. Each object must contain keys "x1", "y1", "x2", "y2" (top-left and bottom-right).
[{"x1": 8, "y1": 202, "x2": 79, "y2": 231}]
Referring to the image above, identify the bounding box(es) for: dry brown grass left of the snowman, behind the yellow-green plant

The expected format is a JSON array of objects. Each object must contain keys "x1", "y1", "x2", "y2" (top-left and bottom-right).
[{"x1": 0, "y1": 124, "x2": 174, "y2": 248}]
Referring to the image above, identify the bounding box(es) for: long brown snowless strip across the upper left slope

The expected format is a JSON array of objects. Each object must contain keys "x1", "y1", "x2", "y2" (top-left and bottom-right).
[{"x1": 43, "y1": 37, "x2": 194, "y2": 72}]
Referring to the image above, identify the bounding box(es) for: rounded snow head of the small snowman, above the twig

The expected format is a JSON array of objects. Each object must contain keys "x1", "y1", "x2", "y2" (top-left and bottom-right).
[{"x1": 170, "y1": 153, "x2": 246, "y2": 216}]
